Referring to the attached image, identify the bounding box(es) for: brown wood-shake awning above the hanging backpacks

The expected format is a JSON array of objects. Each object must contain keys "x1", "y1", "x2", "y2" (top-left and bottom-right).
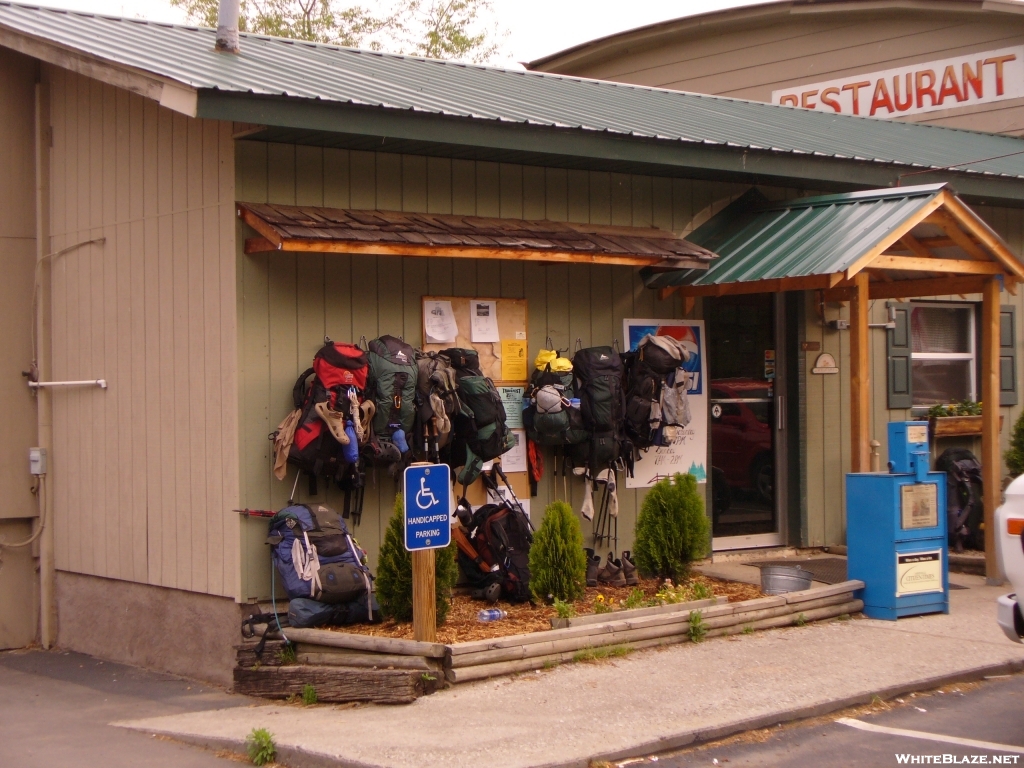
[{"x1": 237, "y1": 203, "x2": 716, "y2": 269}]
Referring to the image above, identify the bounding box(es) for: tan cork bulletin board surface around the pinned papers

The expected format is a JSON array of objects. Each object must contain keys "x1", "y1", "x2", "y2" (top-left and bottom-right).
[{"x1": 423, "y1": 296, "x2": 532, "y2": 385}]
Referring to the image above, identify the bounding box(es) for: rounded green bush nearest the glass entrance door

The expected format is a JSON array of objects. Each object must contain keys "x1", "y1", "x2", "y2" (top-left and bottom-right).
[{"x1": 633, "y1": 474, "x2": 710, "y2": 582}]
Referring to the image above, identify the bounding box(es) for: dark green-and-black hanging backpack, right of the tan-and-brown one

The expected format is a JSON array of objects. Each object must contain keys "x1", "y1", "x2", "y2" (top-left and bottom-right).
[{"x1": 441, "y1": 348, "x2": 515, "y2": 485}]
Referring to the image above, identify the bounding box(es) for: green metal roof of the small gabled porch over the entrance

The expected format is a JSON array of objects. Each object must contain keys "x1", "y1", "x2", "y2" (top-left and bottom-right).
[{"x1": 641, "y1": 184, "x2": 946, "y2": 288}]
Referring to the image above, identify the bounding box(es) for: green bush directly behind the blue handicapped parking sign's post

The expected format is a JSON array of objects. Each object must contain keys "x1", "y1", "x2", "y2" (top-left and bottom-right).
[{"x1": 377, "y1": 494, "x2": 459, "y2": 624}]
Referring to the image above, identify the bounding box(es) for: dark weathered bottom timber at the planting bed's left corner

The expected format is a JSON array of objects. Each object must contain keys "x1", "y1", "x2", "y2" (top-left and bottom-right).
[{"x1": 234, "y1": 665, "x2": 427, "y2": 703}]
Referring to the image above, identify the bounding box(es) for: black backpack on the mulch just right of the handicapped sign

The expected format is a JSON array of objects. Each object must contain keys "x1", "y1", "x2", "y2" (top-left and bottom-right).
[{"x1": 452, "y1": 504, "x2": 534, "y2": 603}]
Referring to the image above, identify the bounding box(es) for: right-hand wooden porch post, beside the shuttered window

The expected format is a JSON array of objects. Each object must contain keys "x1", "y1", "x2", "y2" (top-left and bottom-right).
[{"x1": 981, "y1": 278, "x2": 1002, "y2": 584}]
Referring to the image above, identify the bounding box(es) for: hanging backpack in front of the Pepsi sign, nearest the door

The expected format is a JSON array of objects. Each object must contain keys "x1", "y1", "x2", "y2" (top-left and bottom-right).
[{"x1": 623, "y1": 334, "x2": 690, "y2": 451}]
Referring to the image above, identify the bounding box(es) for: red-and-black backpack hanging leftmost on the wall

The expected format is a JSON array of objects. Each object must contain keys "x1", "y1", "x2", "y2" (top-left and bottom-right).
[{"x1": 284, "y1": 338, "x2": 368, "y2": 506}]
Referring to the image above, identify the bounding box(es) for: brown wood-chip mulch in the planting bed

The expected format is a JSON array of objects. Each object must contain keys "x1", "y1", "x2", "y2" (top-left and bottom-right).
[{"x1": 337, "y1": 574, "x2": 764, "y2": 644}]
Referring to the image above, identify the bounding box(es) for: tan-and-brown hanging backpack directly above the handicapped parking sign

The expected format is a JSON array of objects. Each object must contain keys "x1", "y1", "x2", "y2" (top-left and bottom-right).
[{"x1": 414, "y1": 350, "x2": 462, "y2": 462}]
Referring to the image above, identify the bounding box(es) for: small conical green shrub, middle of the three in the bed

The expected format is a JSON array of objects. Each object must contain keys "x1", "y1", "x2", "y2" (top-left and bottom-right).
[{"x1": 529, "y1": 502, "x2": 587, "y2": 602}]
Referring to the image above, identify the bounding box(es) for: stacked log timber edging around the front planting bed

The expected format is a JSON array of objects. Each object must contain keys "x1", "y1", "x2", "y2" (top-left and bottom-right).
[{"x1": 236, "y1": 581, "x2": 864, "y2": 703}]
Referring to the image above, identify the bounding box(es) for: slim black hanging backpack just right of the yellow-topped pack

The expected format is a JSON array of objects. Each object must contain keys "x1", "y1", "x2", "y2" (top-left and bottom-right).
[{"x1": 572, "y1": 347, "x2": 633, "y2": 475}]
